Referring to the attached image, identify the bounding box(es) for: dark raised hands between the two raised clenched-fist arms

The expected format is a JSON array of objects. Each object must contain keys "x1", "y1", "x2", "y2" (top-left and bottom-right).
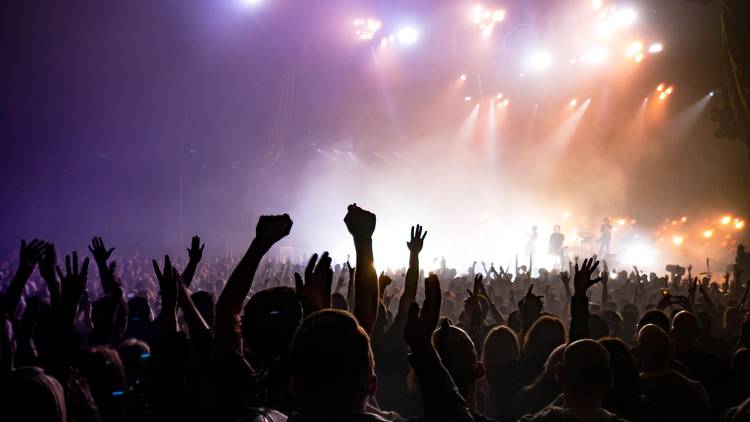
[{"x1": 294, "y1": 252, "x2": 333, "y2": 315}]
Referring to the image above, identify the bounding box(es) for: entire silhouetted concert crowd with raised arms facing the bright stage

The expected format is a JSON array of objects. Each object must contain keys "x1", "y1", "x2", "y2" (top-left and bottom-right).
[{"x1": 0, "y1": 204, "x2": 750, "y2": 422}]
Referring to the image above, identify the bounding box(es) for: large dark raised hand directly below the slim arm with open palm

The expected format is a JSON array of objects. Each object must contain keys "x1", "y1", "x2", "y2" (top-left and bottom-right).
[{"x1": 404, "y1": 274, "x2": 442, "y2": 353}]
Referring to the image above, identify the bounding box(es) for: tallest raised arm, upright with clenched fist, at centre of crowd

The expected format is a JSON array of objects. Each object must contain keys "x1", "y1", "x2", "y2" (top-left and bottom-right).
[{"x1": 344, "y1": 204, "x2": 378, "y2": 333}]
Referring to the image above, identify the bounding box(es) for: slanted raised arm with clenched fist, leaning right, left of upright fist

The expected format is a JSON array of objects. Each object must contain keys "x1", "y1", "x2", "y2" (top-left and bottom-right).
[{"x1": 215, "y1": 214, "x2": 292, "y2": 354}]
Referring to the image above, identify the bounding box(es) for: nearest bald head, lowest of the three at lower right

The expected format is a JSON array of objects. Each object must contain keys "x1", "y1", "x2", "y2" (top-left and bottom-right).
[{"x1": 557, "y1": 339, "x2": 612, "y2": 400}]
